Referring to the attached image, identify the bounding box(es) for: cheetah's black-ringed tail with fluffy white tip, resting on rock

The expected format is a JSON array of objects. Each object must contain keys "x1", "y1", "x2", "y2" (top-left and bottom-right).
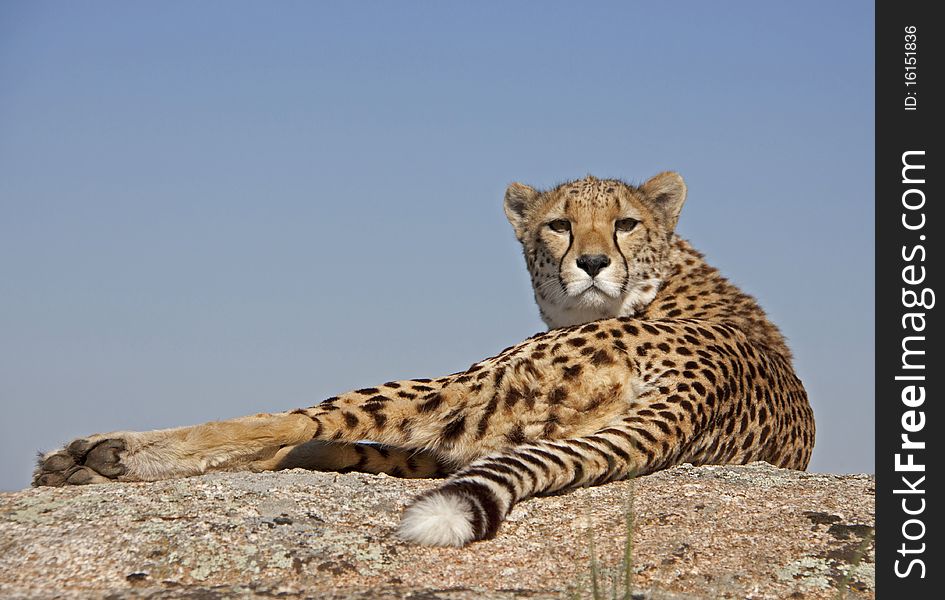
[{"x1": 398, "y1": 426, "x2": 650, "y2": 546}]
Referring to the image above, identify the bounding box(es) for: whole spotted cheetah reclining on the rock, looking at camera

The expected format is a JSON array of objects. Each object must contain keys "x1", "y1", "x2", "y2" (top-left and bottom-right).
[{"x1": 33, "y1": 172, "x2": 814, "y2": 546}]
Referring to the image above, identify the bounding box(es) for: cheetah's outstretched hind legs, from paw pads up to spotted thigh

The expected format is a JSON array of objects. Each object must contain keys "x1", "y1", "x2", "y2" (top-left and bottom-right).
[{"x1": 34, "y1": 330, "x2": 632, "y2": 485}]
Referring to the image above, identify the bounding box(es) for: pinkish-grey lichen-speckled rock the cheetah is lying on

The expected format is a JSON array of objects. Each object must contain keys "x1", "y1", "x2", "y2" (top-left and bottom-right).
[{"x1": 0, "y1": 463, "x2": 875, "y2": 600}]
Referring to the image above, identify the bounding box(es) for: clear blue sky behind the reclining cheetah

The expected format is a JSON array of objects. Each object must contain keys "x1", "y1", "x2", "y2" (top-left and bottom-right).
[{"x1": 0, "y1": 1, "x2": 873, "y2": 489}]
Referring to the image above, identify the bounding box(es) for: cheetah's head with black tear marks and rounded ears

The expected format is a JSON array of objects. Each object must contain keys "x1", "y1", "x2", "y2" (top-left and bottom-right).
[{"x1": 505, "y1": 173, "x2": 686, "y2": 328}]
